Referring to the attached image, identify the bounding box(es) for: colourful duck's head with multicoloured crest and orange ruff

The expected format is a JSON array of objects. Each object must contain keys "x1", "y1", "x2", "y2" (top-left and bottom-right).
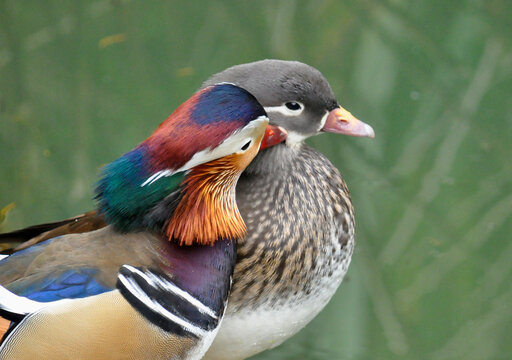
[{"x1": 96, "y1": 83, "x2": 268, "y2": 245}]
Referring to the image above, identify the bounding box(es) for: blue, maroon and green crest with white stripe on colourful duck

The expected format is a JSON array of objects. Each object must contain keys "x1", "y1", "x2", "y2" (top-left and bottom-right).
[{"x1": 96, "y1": 84, "x2": 265, "y2": 238}]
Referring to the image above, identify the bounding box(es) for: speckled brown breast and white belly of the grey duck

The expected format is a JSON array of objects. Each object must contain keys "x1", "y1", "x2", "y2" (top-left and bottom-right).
[{"x1": 205, "y1": 144, "x2": 355, "y2": 360}]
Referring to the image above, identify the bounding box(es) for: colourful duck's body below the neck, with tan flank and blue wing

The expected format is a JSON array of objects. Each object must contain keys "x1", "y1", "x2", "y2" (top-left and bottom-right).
[{"x1": 0, "y1": 226, "x2": 236, "y2": 360}]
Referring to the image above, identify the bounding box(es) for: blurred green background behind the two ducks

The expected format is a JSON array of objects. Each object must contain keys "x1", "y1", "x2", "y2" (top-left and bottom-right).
[{"x1": 0, "y1": 0, "x2": 512, "y2": 359}]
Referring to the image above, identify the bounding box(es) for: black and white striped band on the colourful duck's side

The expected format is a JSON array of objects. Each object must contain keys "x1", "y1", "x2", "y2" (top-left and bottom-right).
[{"x1": 117, "y1": 265, "x2": 220, "y2": 338}]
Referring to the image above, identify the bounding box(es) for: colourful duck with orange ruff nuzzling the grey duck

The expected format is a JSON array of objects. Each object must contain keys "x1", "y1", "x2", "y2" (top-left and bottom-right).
[{"x1": 0, "y1": 84, "x2": 268, "y2": 360}]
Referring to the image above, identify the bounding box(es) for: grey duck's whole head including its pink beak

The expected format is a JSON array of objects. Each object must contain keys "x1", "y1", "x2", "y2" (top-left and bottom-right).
[{"x1": 203, "y1": 60, "x2": 375, "y2": 148}]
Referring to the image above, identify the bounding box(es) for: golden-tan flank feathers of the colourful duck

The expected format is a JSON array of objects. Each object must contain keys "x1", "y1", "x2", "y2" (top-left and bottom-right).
[{"x1": 0, "y1": 290, "x2": 198, "y2": 360}]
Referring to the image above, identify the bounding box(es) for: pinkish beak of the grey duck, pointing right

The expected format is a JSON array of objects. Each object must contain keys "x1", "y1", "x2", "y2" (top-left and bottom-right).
[{"x1": 322, "y1": 106, "x2": 375, "y2": 138}]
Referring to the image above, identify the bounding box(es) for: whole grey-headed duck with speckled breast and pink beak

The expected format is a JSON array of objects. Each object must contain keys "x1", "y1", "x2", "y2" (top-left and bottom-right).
[{"x1": 0, "y1": 60, "x2": 374, "y2": 359}]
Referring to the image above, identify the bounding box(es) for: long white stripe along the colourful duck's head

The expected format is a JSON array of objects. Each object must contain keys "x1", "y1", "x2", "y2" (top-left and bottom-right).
[{"x1": 140, "y1": 115, "x2": 268, "y2": 187}]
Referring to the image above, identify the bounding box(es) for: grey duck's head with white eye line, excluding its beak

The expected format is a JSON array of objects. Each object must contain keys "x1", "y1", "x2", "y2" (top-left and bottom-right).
[{"x1": 203, "y1": 60, "x2": 339, "y2": 143}]
